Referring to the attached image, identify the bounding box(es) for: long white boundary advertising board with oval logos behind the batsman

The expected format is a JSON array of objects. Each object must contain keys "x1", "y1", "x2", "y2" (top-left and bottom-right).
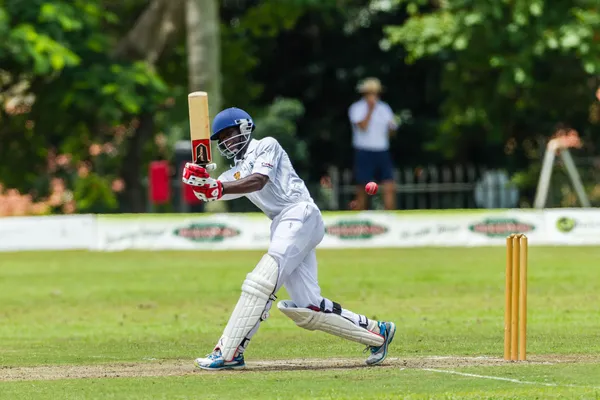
[{"x1": 0, "y1": 209, "x2": 600, "y2": 251}]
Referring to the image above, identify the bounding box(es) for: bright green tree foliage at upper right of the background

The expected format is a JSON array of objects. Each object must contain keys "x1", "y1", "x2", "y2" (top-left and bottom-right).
[{"x1": 386, "y1": 0, "x2": 600, "y2": 160}]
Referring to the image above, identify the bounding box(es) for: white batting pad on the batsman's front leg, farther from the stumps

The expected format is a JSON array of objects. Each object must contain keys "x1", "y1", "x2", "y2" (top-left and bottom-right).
[{"x1": 219, "y1": 254, "x2": 279, "y2": 361}]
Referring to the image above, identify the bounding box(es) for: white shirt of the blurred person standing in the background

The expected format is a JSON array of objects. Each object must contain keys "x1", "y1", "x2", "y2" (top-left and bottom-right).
[{"x1": 348, "y1": 99, "x2": 398, "y2": 151}]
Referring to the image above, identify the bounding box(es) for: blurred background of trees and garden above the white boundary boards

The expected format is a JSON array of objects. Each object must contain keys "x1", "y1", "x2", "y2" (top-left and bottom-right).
[{"x1": 0, "y1": 0, "x2": 600, "y2": 216}]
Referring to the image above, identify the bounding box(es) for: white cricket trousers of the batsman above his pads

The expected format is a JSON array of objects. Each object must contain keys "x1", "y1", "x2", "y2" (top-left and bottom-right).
[{"x1": 268, "y1": 202, "x2": 325, "y2": 307}]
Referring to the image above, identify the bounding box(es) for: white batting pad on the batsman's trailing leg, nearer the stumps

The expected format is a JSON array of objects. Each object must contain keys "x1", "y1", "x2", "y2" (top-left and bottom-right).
[{"x1": 277, "y1": 300, "x2": 383, "y2": 346}]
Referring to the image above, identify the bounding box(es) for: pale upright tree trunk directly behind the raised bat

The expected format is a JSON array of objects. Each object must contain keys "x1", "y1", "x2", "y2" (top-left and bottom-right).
[{"x1": 185, "y1": 0, "x2": 227, "y2": 212}]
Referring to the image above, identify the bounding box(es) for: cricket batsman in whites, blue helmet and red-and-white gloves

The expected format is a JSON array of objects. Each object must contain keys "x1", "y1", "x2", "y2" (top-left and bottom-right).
[{"x1": 182, "y1": 108, "x2": 396, "y2": 370}]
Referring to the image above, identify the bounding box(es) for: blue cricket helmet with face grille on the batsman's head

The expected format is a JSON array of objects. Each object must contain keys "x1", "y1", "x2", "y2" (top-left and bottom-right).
[{"x1": 210, "y1": 107, "x2": 255, "y2": 158}]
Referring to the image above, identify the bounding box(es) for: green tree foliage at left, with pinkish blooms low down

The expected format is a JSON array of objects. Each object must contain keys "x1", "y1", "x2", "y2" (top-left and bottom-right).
[{"x1": 0, "y1": 0, "x2": 168, "y2": 212}]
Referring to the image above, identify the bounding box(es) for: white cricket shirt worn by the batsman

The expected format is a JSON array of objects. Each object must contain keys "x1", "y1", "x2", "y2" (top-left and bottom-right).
[{"x1": 219, "y1": 137, "x2": 314, "y2": 219}]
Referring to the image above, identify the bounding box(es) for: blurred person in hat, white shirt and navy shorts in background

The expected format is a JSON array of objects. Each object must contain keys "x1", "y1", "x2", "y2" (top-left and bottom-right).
[{"x1": 348, "y1": 78, "x2": 398, "y2": 210}]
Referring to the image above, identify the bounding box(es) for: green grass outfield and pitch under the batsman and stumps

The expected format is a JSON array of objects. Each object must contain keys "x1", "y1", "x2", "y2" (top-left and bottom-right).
[{"x1": 0, "y1": 247, "x2": 600, "y2": 399}]
